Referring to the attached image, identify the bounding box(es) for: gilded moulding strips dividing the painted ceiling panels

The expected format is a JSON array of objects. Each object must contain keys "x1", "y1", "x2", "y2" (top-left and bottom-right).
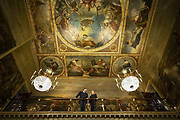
[{"x1": 26, "y1": 0, "x2": 158, "y2": 78}]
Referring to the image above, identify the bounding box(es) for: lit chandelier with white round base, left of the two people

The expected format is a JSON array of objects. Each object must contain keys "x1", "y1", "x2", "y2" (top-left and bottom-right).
[{"x1": 30, "y1": 68, "x2": 58, "y2": 92}]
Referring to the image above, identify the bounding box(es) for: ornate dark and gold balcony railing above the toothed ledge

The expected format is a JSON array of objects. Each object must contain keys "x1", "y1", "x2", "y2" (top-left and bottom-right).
[{"x1": 4, "y1": 97, "x2": 177, "y2": 112}]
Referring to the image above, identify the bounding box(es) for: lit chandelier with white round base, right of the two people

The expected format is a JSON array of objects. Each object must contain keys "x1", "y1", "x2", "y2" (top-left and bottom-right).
[{"x1": 115, "y1": 68, "x2": 142, "y2": 92}]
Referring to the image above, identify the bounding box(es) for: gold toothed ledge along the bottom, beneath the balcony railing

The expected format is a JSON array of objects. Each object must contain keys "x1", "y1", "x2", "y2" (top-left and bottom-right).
[{"x1": 0, "y1": 111, "x2": 180, "y2": 120}]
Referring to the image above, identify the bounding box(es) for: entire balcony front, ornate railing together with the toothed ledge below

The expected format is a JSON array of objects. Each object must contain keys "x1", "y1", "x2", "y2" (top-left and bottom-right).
[{"x1": 0, "y1": 97, "x2": 180, "y2": 120}]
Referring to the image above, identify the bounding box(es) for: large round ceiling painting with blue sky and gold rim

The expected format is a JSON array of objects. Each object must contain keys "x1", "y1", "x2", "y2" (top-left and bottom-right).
[{"x1": 53, "y1": 0, "x2": 124, "y2": 51}]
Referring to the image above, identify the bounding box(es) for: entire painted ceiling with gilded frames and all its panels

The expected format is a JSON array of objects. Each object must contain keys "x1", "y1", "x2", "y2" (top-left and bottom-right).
[{"x1": 28, "y1": 0, "x2": 154, "y2": 77}]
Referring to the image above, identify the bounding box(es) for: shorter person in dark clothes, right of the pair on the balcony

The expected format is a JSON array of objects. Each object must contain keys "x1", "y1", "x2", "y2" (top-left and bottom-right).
[{"x1": 89, "y1": 90, "x2": 97, "y2": 111}]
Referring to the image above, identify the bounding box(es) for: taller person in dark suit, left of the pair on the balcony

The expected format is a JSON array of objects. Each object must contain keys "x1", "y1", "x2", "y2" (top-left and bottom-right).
[{"x1": 76, "y1": 88, "x2": 88, "y2": 111}]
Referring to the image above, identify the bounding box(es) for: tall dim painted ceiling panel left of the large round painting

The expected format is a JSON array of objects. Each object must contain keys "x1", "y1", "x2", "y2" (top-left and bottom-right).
[{"x1": 29, "y1": 0, "x2": 56, "y2": 54}]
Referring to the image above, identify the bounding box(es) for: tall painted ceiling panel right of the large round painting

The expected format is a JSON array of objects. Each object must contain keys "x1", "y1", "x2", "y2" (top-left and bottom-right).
[{"x1": 122, "y1": 0, "x2": 152, "y2": 54}]
